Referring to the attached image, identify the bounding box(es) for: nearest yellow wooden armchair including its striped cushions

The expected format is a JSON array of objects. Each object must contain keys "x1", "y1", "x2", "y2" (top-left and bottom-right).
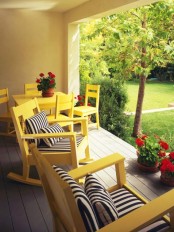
[{"x1": 30, "y1": 144, "x2": 174, "y2": 232}]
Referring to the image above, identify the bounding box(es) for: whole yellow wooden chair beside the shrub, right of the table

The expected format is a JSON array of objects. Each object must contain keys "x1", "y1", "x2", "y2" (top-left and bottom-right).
[{"x1": 74, "y1": 84, "x2": 100, "y2": 129}]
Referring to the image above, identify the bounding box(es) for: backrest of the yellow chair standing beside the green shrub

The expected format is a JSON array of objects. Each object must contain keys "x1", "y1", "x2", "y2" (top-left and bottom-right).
[{"x1": 85, "y1": 84, "x2": 100, "y2": 109}]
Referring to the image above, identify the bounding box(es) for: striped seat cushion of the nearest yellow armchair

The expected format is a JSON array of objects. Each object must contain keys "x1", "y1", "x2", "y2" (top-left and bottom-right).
[{"x1": 110, "y1": 188, "x2": 169, "y2": 232}]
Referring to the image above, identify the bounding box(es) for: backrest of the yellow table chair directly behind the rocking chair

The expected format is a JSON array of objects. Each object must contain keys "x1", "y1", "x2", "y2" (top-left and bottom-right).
[{"x1": 55, "y1": 93, "x2": 74, "y2": 118}]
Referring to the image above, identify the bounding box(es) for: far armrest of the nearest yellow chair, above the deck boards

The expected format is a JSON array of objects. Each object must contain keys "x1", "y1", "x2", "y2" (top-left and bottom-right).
[{"x1": 68, "y1": 153, "x2": 125, "y2": 179}]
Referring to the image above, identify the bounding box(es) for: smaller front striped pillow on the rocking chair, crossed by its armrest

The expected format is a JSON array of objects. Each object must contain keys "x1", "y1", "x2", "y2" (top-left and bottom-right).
[{"x1": 40, "y1": 123, "x2": 64, "y2": 147}]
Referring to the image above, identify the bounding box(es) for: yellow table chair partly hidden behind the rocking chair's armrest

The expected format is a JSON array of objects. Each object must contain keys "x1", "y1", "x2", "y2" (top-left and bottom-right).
[{"x1": 47, "y1": 93, "x2": 74, "y2": 131}]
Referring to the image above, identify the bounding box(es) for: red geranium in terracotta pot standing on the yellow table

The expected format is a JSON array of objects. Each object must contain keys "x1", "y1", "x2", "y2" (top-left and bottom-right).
[{"x1": 36, "y1": 72, "x2": 56, "y2": 97}]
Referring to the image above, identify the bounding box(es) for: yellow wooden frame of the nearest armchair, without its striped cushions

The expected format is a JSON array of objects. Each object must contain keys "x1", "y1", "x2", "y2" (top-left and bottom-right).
[{"x1": 31, "y1": 144, "x2": 174, "y2": 232}]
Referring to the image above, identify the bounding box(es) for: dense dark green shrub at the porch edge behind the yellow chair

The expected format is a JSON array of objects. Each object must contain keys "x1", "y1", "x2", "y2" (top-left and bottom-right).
[{"x1": 81, "y1": 78, "x2": 129, "y2": 139}]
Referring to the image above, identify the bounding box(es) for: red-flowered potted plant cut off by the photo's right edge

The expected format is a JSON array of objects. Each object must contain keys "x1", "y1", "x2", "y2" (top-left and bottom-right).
[{"x1": 160, "y1": 151, "x2": 174, "y2": 186}]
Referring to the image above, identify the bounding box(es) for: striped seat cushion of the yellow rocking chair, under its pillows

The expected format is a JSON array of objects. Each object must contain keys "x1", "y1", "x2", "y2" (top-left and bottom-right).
[{"x1": 38, "y1": 135, "x2": 84, "y2": 152}]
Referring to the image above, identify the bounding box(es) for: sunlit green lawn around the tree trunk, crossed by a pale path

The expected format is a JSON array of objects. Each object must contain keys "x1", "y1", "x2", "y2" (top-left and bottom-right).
[{"x1": 126, "y1": 82, "x2": 174, "y2": 150}]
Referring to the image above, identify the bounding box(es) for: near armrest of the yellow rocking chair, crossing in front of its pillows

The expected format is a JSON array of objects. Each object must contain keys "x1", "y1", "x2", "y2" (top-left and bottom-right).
[{"x1": 21, "y1": 132, "x2": 76, "y2": 139}]
